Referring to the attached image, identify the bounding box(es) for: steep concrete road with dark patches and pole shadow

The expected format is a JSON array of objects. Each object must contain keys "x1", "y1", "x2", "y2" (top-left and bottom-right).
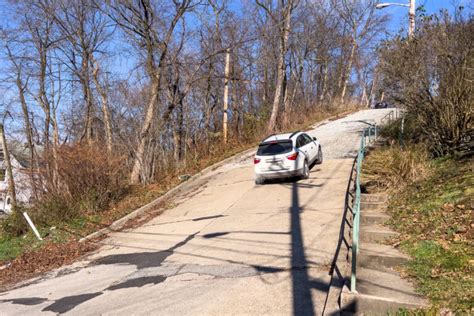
[{"x1": 0, "y1": 110, "x2": 390, "y2": 315}]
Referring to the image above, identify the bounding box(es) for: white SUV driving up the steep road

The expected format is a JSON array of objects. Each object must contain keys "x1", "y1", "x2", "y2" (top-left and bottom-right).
[{"x1": 253, "y1": 132, "x2": 323, "y2": 184}]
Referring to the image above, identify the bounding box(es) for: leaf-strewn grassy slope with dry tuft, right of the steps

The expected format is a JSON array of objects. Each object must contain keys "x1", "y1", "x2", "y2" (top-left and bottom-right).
[{"x1": 364, "y1": 147, "x2": 474, "y2": 314}]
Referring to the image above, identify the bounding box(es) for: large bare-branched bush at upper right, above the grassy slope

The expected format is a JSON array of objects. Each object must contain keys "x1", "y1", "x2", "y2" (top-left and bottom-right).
[{"x1": 380, "y1": 15, "x2": 474, "y2": 156}]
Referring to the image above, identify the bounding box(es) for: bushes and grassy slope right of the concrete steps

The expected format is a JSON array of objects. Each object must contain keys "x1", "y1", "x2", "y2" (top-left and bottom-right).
[{"x1": 363, "y1": 12, "x2": 474, "y2": 315}]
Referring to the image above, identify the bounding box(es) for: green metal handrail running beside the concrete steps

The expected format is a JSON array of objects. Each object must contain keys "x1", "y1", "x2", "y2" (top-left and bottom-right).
[{"x1": 351, "y1": 109, "x2": 399, "y2": 292}]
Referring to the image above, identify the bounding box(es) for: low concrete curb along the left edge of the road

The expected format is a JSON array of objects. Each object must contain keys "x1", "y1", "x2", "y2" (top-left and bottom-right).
[{"x1": 79, "y1": 110, "x2": 354, "y2": 242}]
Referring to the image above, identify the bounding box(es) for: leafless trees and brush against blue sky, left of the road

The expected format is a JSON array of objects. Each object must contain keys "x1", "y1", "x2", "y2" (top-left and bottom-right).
[{"x1": 0, "y1": 0, "x2": 387, "y2": 227}]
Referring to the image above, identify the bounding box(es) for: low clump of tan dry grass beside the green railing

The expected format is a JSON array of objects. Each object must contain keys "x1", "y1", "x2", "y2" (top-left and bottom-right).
[{"x1": 362, "y1": 145, "x2": 428, "y2": 191}]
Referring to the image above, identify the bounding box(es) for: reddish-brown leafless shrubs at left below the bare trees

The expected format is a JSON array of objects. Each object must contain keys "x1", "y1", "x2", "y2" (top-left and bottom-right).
[{"x1": 2, "y1": 143, "x2": 128, "y2": 236}]
